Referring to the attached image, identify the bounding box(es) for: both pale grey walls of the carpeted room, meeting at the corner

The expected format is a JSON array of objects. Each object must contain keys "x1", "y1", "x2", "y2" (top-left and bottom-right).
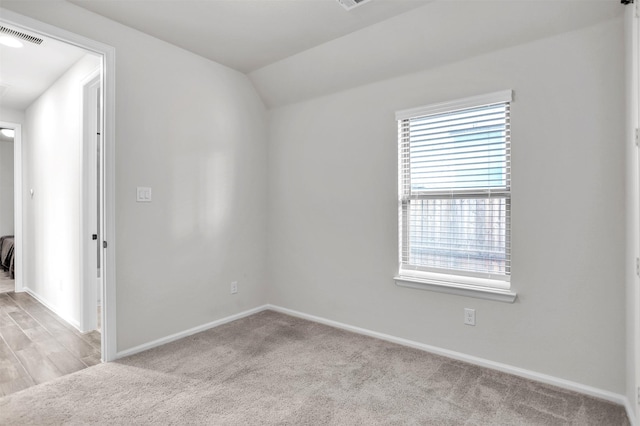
[{"x1": 2, "y1": 1, "x2": 625, "y2": 402}]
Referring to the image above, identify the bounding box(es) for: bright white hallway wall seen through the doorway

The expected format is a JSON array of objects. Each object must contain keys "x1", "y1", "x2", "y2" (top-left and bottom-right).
[{"x1": 22, "y1": 55, "x2": 100, "y2": 327}]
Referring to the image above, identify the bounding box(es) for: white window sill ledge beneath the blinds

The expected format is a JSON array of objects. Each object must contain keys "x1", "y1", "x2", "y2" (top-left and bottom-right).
[{"x1": 394, "y1": 276, "x2": 518, "y2": 303}]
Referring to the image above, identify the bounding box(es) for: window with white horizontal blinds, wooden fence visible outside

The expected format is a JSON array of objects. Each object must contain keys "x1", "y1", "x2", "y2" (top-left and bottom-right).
[{"x1": 396, "y1": 91, "x2": 515, "y2": 301}]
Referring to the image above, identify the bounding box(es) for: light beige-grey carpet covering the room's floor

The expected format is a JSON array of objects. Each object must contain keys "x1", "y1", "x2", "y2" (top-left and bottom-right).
[{"x1": 0, "y1": 311, "x2": 628, "y2": 425}]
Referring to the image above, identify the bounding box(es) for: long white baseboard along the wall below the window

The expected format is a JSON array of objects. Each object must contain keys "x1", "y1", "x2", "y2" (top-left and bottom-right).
[{"x1": 267, "y1": 305, "x2": 635, "y2": 410}]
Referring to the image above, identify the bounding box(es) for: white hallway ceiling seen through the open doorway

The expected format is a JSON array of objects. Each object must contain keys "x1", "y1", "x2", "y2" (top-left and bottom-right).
[{"x1": 0, "y1": 25, "x2": 86, "y2": 111}]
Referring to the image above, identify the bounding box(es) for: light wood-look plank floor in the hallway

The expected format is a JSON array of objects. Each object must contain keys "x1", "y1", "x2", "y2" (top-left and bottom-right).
[{"x1": 0, "y1": 291, "x2": 100, "y2": 396}]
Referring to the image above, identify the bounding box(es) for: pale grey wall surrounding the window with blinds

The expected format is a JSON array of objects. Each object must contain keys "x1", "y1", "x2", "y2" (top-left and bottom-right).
[{"x1": 269, "y1": 18, "x2": 625, "y2": 394}]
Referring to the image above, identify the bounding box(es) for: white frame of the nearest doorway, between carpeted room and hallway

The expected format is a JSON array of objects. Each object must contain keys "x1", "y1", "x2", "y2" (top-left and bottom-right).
[{"x1": 0, "y1": 8, "x2": 117, "y2": 362}]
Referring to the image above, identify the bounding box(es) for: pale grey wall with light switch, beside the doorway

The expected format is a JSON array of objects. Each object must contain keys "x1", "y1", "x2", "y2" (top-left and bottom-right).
[{"x1": 0, "y1": 1, "x2": 267, "y2": 352}]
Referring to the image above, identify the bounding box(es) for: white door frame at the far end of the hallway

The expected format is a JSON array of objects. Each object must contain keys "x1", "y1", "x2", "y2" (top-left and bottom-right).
[{"x1": 0, "y1": 121, "x2": 24, "y2": 292}]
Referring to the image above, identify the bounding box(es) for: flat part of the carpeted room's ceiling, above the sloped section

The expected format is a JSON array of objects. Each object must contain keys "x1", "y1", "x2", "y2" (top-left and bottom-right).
[{"x1": 69, "y1": 0, "x2": 432, "y2": 73}]
